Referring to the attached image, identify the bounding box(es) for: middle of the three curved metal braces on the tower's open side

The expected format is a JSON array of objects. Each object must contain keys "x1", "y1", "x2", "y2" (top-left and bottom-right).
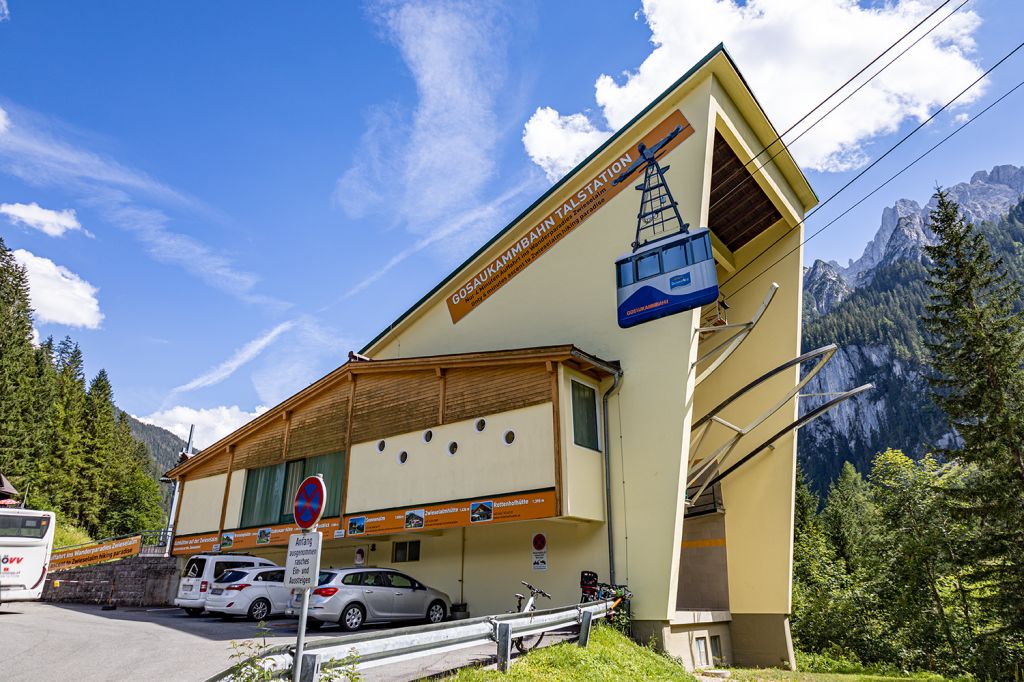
[{"x1": 686, "y1": 343, "x2": 839, "y2": 500}]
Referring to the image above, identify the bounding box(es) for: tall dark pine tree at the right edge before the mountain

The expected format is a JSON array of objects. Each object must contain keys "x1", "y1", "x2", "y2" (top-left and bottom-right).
[{"x1": 924, "y1": 189, "x2": 1024, "y2": 665}]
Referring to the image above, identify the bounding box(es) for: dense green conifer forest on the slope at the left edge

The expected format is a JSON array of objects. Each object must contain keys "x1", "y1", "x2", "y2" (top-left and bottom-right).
[{"x1": 0, "y1": 240, "x2": 165, "y2": 538}]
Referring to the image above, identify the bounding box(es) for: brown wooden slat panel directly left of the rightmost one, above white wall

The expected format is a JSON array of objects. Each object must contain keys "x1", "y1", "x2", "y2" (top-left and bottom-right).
[{"x1": 352, "y1": 371, "x2": 440, "y2": 442}]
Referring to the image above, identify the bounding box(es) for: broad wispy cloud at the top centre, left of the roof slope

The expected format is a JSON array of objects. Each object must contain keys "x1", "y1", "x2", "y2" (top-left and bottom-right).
[{"x1": 336, "y1": 2, "x2": 505, "y2": 235}]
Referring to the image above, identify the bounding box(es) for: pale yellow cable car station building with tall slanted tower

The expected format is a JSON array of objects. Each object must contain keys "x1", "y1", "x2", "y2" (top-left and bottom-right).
[{"x1": 168, "y1": 46, "x2": 817, "y2": 667}]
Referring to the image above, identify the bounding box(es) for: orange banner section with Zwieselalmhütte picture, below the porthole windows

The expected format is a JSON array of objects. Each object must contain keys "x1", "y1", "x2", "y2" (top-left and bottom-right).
[{"x1": 345, "y1": 488, "x2": 555, "y2": 538}]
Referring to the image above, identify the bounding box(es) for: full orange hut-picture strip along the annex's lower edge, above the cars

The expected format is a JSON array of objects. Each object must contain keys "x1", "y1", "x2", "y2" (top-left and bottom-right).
[{"x1": 171, "y1": 488, "x2": 556, "y2": 555}]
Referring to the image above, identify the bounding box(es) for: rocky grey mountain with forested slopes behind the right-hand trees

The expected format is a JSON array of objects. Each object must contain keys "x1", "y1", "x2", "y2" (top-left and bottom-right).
[{"x1": 799, "y1": 166, "x2": 1024, "y2": 493}]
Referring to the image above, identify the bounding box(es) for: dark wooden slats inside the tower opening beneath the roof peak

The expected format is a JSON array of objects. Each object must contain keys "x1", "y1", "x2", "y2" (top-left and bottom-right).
[{"x1": 708, "y1": 132, "x2": 782, "y2": 252}]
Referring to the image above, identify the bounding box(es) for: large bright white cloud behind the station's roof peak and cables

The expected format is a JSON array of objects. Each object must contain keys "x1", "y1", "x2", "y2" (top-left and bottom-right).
[{"x1": 523, "y1": 0, "x2": 984, "y2": 177}]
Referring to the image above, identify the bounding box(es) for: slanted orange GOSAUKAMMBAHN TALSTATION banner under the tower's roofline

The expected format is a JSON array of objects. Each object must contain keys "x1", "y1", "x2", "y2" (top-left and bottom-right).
[{"x1": 447, "y1": 111, "x2": 693, "y2": 323}]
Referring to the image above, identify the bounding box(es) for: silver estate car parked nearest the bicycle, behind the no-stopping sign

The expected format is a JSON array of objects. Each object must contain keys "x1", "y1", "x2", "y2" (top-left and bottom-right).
[{"x1": 286, "y1": 568, "x2": 452, "y2": 632}]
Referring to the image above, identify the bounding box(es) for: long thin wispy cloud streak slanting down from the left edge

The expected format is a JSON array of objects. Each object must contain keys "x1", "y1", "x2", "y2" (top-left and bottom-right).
[{"x1": 0, "y1": 105, "x2": 288, "y2": 308}]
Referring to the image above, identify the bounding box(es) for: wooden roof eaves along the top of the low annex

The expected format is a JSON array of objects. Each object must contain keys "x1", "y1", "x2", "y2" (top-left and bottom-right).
[{"x1": 164, "y1": 344, "x2": 622, "y2": 478}]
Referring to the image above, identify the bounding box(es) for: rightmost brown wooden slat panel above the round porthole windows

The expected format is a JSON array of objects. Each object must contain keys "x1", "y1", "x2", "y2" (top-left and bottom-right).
[{"x1": 444, "y1": 365, "x2": 551, "y2": 424}]
